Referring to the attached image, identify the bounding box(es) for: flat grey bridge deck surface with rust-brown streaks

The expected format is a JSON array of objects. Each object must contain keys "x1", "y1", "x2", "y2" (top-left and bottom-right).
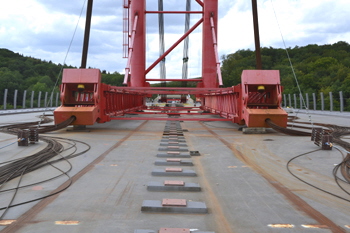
[{"x1": 0, "y1": 113, "x2": 350, "y2": 233}]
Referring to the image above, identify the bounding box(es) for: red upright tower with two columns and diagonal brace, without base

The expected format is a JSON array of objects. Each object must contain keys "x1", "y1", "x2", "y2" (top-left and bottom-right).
[{"x1": 124, "y1": 0, "x2": 222, "y2": 88}]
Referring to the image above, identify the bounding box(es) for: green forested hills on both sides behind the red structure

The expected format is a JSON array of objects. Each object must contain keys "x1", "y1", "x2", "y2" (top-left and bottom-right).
[{"x1": 0, "y1": 41, "x2": 350, "y2": 108}]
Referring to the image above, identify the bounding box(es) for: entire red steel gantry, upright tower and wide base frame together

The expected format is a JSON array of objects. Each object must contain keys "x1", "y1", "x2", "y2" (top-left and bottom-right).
[{"x1": 54, "y1": 0, "x2": 287, "y2": 127}]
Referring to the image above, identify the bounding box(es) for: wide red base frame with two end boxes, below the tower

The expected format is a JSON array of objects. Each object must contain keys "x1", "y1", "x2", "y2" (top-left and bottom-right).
[{"x1": 54, "y1": 69, "x2": 287, "y2": 127}]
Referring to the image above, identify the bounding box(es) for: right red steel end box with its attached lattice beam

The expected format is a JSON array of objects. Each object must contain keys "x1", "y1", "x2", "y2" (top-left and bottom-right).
[{"x1": 202, "y1": 70, "x2": 287, "y2": 127}]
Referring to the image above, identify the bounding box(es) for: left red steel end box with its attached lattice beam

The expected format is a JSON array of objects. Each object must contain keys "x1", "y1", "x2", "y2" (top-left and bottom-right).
[{"x1": 54, "y1": 69, "x2": 146, "y2": 125}]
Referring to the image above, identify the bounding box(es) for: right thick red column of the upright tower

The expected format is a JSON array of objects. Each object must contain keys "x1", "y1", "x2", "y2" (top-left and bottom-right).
[{"x1": 202, "y1": 0, "x2": 219, "y2": 88}]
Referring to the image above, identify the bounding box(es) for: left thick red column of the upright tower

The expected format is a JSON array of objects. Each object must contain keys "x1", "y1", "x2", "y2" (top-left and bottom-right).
[{"x1": 130, "y1": 0, "x2": 146, "y2": 87}]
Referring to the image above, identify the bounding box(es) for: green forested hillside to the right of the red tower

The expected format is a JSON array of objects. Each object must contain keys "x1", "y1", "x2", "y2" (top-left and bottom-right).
[{"x1": 221, "y1": 41, "x2": 350, "y2": 97}]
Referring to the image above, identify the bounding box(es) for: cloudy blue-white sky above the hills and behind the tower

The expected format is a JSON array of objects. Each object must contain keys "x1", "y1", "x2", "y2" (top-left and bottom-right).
[{"x1": 0, "y1": 0, "x2": 350, "y2": 78}]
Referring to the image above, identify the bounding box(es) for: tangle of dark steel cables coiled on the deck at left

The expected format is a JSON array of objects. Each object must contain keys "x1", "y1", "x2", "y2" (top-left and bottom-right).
[{"x1": 0, "y1": 116, "x2": 90, "y2": 219}]
